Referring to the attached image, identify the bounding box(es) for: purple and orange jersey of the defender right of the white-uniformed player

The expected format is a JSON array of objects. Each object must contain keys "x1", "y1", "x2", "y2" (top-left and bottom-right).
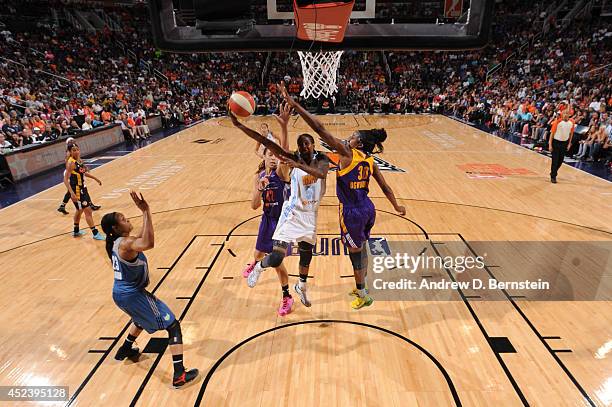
[{"x1": 336, "y1": 149, "x2": 374, "y2": 207}]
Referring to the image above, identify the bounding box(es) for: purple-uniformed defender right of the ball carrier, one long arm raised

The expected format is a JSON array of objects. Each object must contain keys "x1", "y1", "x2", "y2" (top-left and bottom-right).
[{"x1": 280, "y1": 84, "x2": 406, "y2": 309}]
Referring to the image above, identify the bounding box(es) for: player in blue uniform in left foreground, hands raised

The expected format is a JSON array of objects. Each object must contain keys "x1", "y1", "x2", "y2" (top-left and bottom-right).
[{"x1": 102, "y1": 191, "x2": 198, "y2": 388}]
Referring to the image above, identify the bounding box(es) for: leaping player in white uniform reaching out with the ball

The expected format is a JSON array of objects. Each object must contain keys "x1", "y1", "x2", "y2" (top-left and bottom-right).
[{"x1": 229, "y1": 103, "x2": 329, "y2": 316}]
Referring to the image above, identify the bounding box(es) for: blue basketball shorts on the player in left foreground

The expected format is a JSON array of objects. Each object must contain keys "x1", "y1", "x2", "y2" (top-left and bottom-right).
[{"x1": 113, "y1": 290, "x2": 176, "y2": 334}]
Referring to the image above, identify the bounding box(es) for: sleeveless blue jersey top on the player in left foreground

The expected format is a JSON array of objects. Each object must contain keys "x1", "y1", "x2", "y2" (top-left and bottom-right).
[{"x1": 111, "y1": 237, "x2": 149, "y2": 293}]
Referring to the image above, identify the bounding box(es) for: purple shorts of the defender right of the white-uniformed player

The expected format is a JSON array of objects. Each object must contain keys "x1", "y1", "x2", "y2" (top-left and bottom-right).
[{"x1": 339, "y1": 200, "x2": 376, "y2": 249}]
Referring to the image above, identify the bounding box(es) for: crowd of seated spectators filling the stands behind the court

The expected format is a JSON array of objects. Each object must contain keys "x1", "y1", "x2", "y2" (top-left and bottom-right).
[{"x1": 0, "y1": 0, "x2": 612, "y2": 166}]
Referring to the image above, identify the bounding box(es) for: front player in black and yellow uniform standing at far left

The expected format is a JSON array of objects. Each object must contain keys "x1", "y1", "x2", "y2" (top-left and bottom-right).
[{"x1": 64, "y1": 143, "x2": 105, "y2": 240}]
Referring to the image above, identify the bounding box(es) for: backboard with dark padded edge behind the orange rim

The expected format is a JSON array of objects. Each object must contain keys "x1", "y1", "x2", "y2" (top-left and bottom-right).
[{"x1": 149, "y1": 0, "x2": 494, "y2": 52}]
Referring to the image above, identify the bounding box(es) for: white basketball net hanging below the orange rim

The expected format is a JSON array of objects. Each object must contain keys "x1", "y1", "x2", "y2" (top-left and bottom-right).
[{"x1": 298, "y1": 51, "x2": 344, "y2": 98}]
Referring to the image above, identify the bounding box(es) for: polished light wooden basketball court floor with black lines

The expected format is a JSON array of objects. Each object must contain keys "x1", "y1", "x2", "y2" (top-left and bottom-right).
[{"x1": 0, "y1": 116, "x2": 612, "y2": 407}]
